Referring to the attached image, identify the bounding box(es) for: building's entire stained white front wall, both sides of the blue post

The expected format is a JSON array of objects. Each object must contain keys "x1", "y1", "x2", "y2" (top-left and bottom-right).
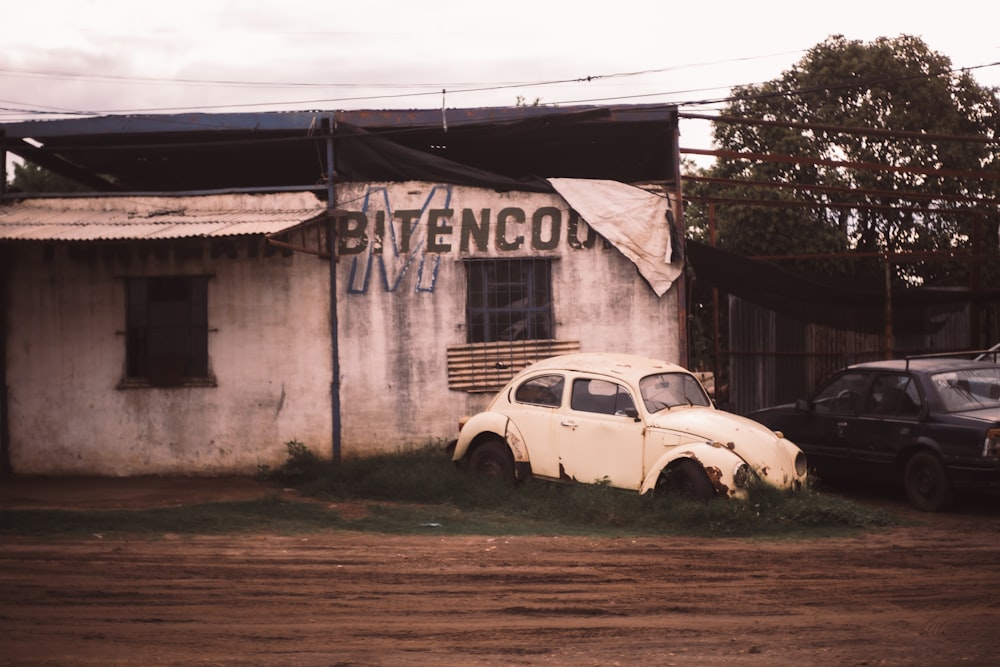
[{"x1": 0, "y1": 183, "x2": 679, "y2": 475}]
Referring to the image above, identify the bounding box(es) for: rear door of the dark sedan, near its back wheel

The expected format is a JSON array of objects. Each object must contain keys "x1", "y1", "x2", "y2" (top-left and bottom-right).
[{"x1": 845, "y1": 372, "x2": 924, "y2": 481}]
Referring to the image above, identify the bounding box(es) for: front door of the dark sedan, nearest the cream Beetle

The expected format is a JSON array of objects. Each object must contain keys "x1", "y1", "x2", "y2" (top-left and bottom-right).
[{"x1": 779, "y1": 371, "x2": 870, "y2": 477}]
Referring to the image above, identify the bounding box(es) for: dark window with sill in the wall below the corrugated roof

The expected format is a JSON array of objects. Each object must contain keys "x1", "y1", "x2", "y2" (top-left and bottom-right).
[{"x1": 125, "y1": 276, "x2": 212, "y2": 387}]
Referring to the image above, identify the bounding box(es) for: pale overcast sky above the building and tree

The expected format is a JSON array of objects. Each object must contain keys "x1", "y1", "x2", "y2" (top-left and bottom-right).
[{"x1": 0, "y1": 0, "x2": 1000, "y2": 158}]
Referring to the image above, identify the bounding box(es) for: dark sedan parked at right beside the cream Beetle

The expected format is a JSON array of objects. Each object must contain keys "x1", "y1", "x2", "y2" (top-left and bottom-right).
[{"x1": 747, "y1": 357, "x2": 1000, "y2": 512}]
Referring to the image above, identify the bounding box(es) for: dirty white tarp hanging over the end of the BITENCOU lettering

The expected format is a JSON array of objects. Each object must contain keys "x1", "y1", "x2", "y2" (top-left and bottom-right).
[{"x1": 549, "y1": 178, "x2": 683, "y2": 296}]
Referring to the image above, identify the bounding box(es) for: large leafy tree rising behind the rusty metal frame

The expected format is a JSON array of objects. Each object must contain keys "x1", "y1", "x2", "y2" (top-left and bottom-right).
[{"x1": 686, "y1": 36, "x2": 1000, "y2": 285}]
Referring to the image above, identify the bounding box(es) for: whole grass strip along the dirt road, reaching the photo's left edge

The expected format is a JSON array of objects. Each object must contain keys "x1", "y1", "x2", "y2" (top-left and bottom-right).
[{"x1": 0, "y1": 441, "x2": 898, "y2": 538}]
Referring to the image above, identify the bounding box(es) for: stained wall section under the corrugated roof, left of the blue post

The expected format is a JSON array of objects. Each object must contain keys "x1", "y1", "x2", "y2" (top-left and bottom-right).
[{"x1": 7, "y1": 241, "x2": 332, "y2": 475}]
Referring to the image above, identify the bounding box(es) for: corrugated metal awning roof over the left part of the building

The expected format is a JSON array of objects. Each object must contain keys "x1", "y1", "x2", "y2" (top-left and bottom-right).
[{"x1": 0, "y1": 192, "x2": 326, "y2": 241}]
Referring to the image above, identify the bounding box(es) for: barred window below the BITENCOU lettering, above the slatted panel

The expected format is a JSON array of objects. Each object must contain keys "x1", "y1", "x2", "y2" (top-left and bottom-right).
[{"x1": 466, "y1": 259, "x2": 553, "y2": 343}]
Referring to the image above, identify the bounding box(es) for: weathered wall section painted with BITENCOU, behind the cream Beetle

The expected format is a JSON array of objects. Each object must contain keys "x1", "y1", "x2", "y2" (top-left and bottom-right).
[{"x1": 337, "y1": 183, "x2": 679, "y2": 455}]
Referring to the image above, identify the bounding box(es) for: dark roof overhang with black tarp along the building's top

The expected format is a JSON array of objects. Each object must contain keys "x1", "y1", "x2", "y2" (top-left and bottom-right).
[{"x1": 0, "y1": 105, "x2": 678, "y2": 193}]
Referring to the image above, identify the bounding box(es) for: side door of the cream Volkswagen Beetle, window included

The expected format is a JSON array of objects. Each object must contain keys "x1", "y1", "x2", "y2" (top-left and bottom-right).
[{"x1": 554, "y1": 376, "x2": 644, "y2": 489}]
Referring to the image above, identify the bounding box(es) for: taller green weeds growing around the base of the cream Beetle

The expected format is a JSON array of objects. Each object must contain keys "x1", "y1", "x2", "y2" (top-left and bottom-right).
[{"x1": 256, "y1": 442, "x2": 896, "y2": 536}]
